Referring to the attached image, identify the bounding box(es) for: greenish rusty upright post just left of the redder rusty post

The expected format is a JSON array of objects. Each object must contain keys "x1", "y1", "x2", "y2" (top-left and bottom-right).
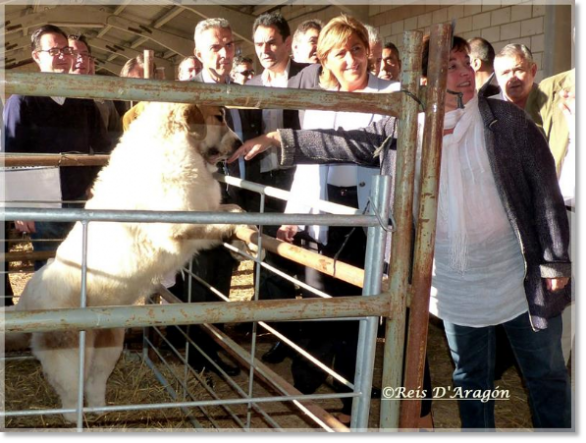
[{"x1": 380, "y1": 31, "x2": 423, "y2": 429}]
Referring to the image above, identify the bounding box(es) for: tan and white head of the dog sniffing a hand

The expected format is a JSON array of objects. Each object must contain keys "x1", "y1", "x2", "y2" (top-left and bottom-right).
[{"x1": 169, "y1": 104, "x2": 242, "y2": 165}]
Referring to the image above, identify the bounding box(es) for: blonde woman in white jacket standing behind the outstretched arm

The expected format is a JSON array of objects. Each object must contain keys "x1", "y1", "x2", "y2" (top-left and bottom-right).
[{"x1": 277, "y1": 15, "x2": 399, "y2": 422}]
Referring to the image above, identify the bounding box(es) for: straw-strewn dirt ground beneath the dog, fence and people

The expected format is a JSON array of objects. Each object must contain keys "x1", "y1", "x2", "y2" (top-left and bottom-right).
[{"x1": 5, "y1": 255, "x2": 544, "y2": 431}]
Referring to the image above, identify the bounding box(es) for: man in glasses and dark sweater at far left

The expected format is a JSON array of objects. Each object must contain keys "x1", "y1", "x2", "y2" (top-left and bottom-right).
[{"x1": 3, "y1": 25, "x2": 111, "y2": 269}]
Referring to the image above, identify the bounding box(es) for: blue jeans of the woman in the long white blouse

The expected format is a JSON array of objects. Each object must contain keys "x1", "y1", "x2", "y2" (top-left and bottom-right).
[{"x1": 444, "y1": 313, "x2": 572, "y2": 428}]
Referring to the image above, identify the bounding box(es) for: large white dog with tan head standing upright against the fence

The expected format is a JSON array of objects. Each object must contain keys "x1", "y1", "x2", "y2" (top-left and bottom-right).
[{"x1": 7, "y1": 103, "x2": 253, "y2": 421}]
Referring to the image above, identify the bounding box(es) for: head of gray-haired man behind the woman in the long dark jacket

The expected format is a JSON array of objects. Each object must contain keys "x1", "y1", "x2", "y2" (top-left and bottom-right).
[{"x1": 494, "y1": 43, "x2": 537, "y2": 109}]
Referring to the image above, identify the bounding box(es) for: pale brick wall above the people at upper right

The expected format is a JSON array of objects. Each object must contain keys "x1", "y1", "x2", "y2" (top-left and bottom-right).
[{"x1": 369, "y1": 1, "x2": 545, "y2": 81}]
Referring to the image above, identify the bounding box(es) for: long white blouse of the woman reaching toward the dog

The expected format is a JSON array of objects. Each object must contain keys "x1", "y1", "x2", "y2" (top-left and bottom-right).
[{"x1": 422, "y1": 97, "x2": 528, "y2": 327}]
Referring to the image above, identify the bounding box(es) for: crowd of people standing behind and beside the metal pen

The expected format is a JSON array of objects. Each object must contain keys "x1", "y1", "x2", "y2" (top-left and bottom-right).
[{"x1": 3, "y1": 12, "x2": 575, "y2": 428}]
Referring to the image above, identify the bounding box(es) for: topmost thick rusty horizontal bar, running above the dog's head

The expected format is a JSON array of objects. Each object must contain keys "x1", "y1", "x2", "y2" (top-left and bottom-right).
[{"x1": 0, "y1": 71, "x2": 402, "y2": 116}]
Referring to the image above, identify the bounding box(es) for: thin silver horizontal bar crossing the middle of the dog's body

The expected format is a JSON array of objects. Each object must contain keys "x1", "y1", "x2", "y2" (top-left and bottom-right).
[{"x1": 3, "y1": 207, "x2": 379, "y2": 226}]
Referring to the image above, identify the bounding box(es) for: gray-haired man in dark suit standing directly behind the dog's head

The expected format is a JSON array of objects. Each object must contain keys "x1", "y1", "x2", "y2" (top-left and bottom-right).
[{"x1": 173, "y1": 18, "x2": 261, "y2": 375}]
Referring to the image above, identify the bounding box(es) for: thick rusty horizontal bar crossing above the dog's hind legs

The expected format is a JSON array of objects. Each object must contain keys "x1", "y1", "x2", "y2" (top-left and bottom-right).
[{"x1": 0, "y1": 294, "x2": 389, "y2": 332}]
